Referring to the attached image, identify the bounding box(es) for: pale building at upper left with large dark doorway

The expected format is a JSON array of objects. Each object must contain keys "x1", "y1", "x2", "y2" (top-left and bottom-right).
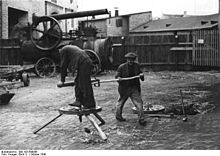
[{"x1": 0, "y1": 0, "x2": 78, "y2": 39}]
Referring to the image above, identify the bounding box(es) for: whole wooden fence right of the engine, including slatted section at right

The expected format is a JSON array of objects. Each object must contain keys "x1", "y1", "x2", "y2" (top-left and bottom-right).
[{"x1": 112, "y1": 29, "x2": 220, "y2": 70}]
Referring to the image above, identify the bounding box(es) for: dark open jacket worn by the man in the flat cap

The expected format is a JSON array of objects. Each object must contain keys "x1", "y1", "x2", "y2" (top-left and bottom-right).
[{"x1": 115, "y1": 62, "x2": 142, "y2": 94}]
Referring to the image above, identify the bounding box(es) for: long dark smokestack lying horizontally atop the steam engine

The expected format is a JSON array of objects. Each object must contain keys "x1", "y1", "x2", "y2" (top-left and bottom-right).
[{"x1": 50, "y1": 9, "x2": 108, "y2": 20}]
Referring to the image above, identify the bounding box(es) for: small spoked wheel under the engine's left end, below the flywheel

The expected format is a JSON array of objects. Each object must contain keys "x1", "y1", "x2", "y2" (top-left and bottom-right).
[{"x1": 34, "y1": 57, "x2": 56, "y2": 78}]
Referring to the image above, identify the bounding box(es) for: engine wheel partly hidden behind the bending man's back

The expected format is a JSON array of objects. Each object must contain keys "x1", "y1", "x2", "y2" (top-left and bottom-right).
[{"x1": 84, "y1": 49, "x2": 101, "y2": 76}]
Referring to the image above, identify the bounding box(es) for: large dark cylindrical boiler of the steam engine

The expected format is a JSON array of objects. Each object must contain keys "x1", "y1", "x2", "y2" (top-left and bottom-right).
[{"x1": 21, "y1": 38, "x2": 113, "y2": 71}]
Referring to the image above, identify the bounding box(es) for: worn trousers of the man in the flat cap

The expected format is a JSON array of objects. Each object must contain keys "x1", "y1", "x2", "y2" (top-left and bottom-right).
[{"x1": 116, "y1": 87, "x2": 144, "y2": 120}]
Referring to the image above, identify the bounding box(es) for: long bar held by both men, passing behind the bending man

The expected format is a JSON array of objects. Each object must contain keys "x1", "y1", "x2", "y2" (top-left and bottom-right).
[{"x1": 57, "y1": 74, "x2": 144, "y2": 88}]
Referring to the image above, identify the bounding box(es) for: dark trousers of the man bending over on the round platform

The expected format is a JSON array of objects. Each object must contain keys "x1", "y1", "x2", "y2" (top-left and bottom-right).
[{"x1": 75, "y1": 59, "x2": 96, "y2": 108}]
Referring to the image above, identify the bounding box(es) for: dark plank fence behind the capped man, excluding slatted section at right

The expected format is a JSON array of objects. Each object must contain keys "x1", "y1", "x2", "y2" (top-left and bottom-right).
[{"x1": 112, "y1": 33, "x2": 192, "y2": 70}]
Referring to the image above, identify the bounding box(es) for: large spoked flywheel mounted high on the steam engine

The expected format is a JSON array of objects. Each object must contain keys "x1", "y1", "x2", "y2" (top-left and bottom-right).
[{"x1": 30, "y1": 16, "x2": 62, "y2": 51}]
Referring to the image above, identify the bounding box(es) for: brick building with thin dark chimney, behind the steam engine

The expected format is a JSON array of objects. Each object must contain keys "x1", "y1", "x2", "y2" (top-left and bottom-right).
[{"x1": 80, "y1": 10, "x2": 152, "y2": 37}]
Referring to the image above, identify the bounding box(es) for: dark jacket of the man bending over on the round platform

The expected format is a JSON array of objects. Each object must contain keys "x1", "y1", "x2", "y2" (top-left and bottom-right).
[{"x1": 60, "y1": 45, "x2": 89, "y2": 82}]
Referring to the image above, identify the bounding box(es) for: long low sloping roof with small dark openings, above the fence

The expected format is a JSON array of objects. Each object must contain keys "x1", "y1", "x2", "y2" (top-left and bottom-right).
[{"x1": 131, "y1": 14, "x2": 218, "y2": 33}]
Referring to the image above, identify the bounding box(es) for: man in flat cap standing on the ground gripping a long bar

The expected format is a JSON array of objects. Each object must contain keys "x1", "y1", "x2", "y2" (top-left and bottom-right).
[{"x1": 115, "y1": 52, "x2": 146, "y2": 126}]
